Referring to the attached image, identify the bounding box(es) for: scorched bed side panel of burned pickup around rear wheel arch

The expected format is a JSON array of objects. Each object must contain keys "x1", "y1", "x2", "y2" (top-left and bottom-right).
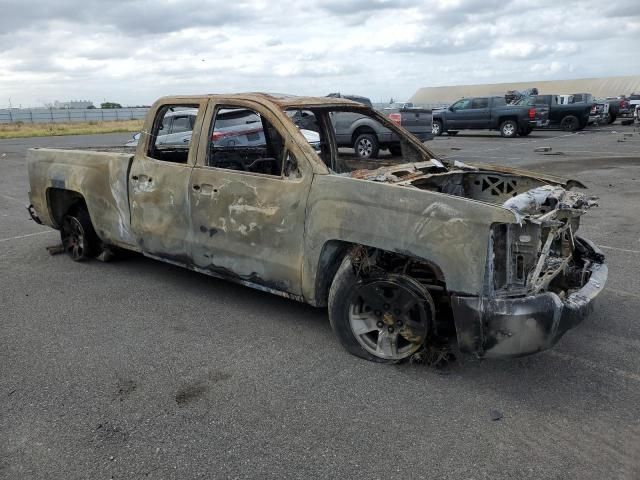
[{"x1": 27, "y1": 148, "x2": 137, "y2": 249}]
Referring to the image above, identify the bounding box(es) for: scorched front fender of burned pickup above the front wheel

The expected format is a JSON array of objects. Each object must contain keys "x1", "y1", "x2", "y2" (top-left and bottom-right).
[{"x1": 304, "y1": 175, "x2": 515, "y2": 298}]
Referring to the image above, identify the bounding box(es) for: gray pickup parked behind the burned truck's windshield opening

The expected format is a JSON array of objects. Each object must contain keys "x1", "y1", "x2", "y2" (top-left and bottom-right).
[{"x1": 327, "y1": 93, "x2": 433, "y2": 158}]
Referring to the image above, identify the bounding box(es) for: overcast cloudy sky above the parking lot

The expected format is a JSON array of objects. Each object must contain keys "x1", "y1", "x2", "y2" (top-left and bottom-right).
[{"x1": 0, "y1": 0, "x2": 640, "y2": 107}]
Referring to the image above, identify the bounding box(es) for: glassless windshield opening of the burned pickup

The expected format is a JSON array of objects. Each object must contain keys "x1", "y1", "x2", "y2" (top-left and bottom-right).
[{"x1": 285, "y1": 107, "x2": 435, "y2": 173}]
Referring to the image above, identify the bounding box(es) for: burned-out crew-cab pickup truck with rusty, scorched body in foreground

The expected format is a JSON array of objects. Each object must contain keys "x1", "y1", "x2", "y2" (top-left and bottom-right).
[{"x1": 27, "y1": 94, "x2": 607, "y2": 362}]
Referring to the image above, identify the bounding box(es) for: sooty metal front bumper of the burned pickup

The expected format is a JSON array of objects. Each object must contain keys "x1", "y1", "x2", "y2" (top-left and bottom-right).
[{"x1": 451, "y1": 238, "x2": 607, "y2": 357}]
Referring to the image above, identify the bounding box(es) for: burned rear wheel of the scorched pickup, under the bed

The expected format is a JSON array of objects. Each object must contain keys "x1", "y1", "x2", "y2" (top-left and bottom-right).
[{"x1": 60, "y1": 207, "x2": 100, "y2": 262}]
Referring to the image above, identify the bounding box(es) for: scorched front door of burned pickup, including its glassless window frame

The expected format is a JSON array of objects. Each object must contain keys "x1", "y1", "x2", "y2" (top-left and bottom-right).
[{"x1": 189, "y1": 101, "x2": 312, "y2": 295}]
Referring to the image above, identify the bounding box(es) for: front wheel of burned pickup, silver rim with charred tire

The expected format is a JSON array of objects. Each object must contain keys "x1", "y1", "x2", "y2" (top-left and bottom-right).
[{"x1": 329, "y1": 257, "x2": 435, "y2": 363}]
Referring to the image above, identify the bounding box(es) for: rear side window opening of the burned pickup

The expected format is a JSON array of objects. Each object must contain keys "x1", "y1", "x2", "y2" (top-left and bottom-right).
[{"x1": 147, "y1": 105, "x2": 198, "y2": 163}]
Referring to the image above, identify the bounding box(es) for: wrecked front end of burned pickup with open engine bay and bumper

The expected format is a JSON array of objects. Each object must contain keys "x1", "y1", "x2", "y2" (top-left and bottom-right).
[{"x1": 342, "y1": 160, "x2": 607, "y2": 357}]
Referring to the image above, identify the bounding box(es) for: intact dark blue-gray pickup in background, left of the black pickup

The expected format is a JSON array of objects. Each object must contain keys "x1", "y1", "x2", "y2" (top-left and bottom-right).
[{"x1": 432, "y1": 97, "x2": 547, "y2": 137}]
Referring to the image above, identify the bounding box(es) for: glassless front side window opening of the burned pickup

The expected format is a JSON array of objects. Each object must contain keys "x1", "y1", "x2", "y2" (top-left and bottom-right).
[{"x1": 207, "y1": 106, "x2": 285, "y2": 176}]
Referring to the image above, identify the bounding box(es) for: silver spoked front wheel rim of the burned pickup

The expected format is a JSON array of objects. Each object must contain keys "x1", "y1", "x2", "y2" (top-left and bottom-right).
[{"x1": 349, "y1": 280, "x2": 429, "y2": 360}]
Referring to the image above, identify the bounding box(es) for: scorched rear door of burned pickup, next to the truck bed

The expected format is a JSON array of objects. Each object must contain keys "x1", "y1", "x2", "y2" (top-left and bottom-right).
[{"x1": 129, "y1": 101, "x2": 206, "y2": 258}]
